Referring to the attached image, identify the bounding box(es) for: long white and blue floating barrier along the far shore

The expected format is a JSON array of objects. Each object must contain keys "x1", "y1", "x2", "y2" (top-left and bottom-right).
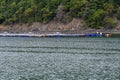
[{"x1": 0, "y1": 33, "x2": 103, "y2": 37}]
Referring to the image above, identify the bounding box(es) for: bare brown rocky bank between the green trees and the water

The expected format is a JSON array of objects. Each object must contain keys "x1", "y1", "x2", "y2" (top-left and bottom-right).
[{"x1": 0, "y1": 19, "x2": 120, "y2": 34}]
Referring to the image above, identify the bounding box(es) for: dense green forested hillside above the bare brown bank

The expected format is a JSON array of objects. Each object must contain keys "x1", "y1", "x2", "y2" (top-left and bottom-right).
[{"x1": 0, "y1": 0, "x2": 120, "y2": 28}]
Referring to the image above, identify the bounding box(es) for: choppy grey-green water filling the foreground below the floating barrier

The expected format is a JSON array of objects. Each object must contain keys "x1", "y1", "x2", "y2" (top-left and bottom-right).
[{"x1": 0, "y1": 37, "x2": 120, "y2": 80}]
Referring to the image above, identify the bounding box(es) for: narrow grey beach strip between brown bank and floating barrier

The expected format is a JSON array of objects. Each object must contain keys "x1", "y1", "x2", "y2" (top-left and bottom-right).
[{"x1": 0, "y1": 29, "x2": 120, "y2": 35}]
